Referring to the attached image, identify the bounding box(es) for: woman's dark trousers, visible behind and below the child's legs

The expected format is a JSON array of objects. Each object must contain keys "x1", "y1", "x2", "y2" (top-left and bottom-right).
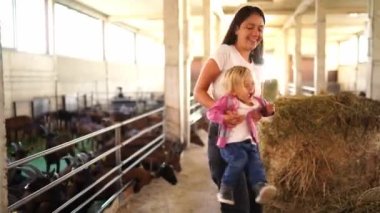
[{"x1": 207, "y1": 123, "x2": 262, "y2": 213}]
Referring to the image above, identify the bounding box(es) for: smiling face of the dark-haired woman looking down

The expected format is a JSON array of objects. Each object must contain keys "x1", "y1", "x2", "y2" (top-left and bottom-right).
[{"x1": 235, "y1": 14, "x2": 264, "y2": 51}]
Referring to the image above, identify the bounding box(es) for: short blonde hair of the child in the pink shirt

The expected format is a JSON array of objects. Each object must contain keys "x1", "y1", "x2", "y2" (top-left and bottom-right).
[{"x1": 224, "y1": 66, "x2": 252, "y2": 93}]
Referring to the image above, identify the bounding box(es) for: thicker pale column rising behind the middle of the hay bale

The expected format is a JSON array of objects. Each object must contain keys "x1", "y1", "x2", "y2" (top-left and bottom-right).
[{"x1": 314, "y1": 0, "x2": 327, "y2": 94}]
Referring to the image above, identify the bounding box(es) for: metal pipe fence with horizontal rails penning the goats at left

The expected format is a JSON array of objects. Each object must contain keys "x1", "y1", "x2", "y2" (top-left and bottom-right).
[{"x1": 7, "y1": 107, "x2": 164, "y2": 212}]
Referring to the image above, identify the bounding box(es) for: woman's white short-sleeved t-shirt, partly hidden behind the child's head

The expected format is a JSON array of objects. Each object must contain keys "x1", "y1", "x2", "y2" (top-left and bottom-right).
[{"x1": 211, "y1": 44, "x2": 261, "y2": 99}]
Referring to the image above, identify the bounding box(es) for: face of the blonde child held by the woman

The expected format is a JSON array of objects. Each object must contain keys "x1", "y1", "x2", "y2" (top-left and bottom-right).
[{"x1": 233, "y1": 75, "x2": 255, "y2": 104}]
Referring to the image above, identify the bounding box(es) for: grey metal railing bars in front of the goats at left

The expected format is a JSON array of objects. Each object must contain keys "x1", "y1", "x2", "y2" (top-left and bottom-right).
[{"x1": 7, "y1": 107, "x2": 164, "y2": 212}]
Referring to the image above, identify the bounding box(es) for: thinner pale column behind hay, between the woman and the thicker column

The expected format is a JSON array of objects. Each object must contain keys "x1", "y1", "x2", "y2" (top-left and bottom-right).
[{"x1": 293, "y1": 16, "x2": 302, "y2": 95}]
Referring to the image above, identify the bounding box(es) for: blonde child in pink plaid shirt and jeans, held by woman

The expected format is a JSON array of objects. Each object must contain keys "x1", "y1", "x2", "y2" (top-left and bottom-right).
[{"x1": 207, "y1": 66, "x2": 277, "y2": 205}]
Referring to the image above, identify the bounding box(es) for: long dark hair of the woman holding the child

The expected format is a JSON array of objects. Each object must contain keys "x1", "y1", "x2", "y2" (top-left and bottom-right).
[{"x1": 223, "y1": 5, "x2": 265, "y2": 64}]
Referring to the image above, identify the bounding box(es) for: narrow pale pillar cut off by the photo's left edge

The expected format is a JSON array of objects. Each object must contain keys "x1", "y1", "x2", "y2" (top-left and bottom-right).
[{"x1": 0, "y1": 29, "x2": 8, "y2": 212}]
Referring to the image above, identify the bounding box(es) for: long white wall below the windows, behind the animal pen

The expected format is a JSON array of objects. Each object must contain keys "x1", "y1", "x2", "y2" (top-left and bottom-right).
[{"x1": 3, "y1": 49, "x2": 164, "y2": 118}]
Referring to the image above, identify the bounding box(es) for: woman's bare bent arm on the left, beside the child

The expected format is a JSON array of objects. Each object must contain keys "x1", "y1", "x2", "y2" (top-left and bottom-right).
[{"x1": 194, "y1": 59, "x2": 221, "y2": 109}]
